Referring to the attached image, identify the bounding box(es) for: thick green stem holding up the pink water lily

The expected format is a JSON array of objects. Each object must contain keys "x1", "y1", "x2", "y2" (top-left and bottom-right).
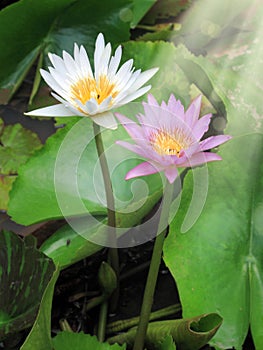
[{"x1": 133, "y1": 181, "x2": 173, "y2": 350}]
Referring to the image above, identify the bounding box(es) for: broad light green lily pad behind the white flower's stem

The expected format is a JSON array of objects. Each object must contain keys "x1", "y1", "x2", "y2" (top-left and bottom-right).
[{"x1": 9, "y1": 106, "x2": 165, "y2": 227}]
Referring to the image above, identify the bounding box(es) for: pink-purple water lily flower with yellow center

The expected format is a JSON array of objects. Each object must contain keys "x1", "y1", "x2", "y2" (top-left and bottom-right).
[{"x1": 116, "y1": 95, "x2": 231, "y2": 183}]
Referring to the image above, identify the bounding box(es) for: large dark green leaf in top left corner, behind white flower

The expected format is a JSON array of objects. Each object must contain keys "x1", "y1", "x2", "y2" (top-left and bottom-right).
[{"x1": 0, "y1": 0, "x2": 131, "y2": 103}]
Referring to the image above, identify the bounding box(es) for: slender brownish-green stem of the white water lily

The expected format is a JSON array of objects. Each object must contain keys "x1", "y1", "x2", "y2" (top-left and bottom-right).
[{"x1": 93, "y1": 123, "x2": 120, "y2": 312}]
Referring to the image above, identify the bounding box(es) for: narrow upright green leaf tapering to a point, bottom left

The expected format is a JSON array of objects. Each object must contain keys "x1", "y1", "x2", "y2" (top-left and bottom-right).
[{"x1": 20, "y1": 268, "x2": 59, "y2": 350}]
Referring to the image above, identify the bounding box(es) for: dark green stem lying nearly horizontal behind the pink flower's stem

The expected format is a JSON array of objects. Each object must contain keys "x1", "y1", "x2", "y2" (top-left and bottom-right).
[{"x1": 106, "y1": 304, "x2": 182, "y2": 334}]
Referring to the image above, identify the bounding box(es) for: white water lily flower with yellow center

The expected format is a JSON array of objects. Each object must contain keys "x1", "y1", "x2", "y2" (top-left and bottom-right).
[{"x1": 26, "y1": 33, "x2": 158, "y2": 129}]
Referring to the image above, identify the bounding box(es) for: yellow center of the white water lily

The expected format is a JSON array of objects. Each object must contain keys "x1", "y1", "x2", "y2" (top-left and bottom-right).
[{"x1": 71, "y1": 75, "x2": 118, "y2": 104}]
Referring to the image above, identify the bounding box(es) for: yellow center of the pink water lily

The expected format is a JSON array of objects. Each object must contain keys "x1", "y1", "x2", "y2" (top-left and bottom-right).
[{"x1": 150, "y1": 130, "x2": 191, "y2": 157}]
